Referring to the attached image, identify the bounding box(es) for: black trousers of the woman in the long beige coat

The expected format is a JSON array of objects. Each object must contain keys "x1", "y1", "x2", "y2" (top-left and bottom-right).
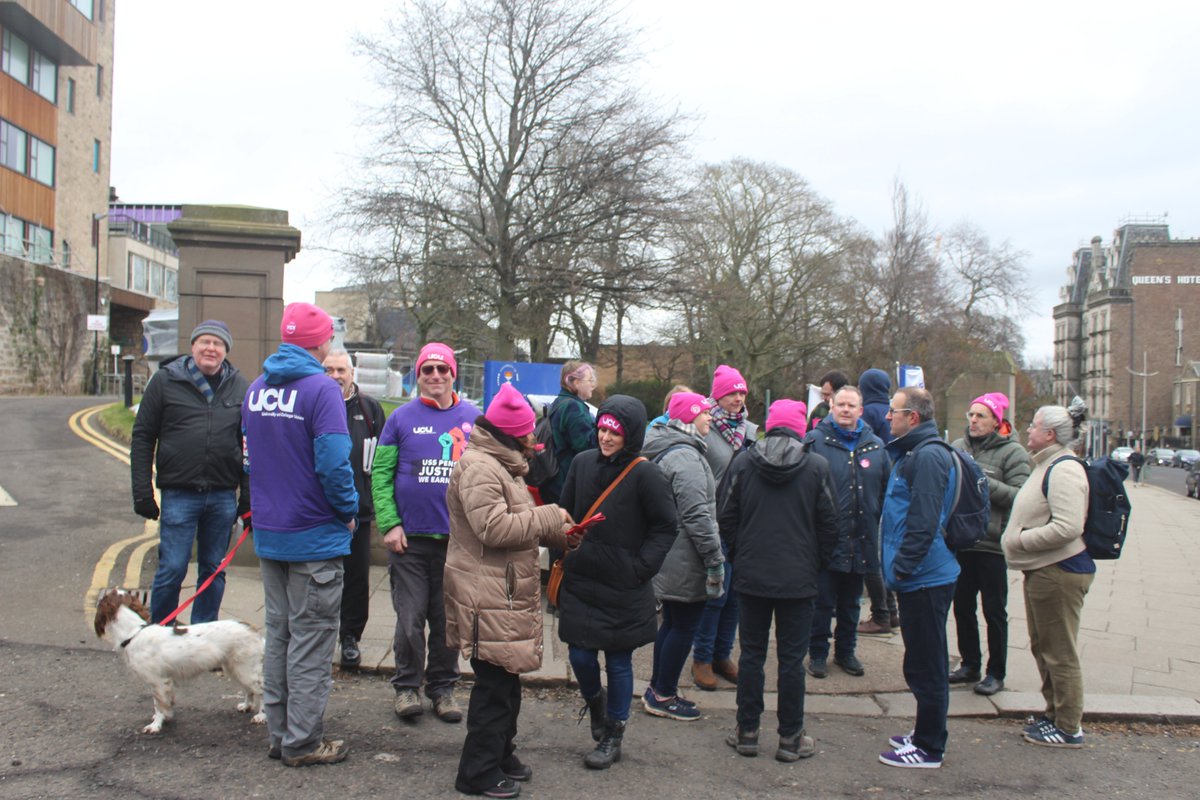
[{"x1": 455, "y1": 658, "x2": 521, "y2": 793}]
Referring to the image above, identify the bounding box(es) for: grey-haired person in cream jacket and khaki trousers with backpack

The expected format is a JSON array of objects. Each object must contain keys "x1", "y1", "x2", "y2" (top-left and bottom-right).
[{"x1": 1000, "y1": 398, "x2": 1096, "y2": 747}]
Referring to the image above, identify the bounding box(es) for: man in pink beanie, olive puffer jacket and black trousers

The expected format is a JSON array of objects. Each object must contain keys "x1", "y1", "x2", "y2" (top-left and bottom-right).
[{"x1": 950, "y1": 392, "x2": 1030, "y2": 696}]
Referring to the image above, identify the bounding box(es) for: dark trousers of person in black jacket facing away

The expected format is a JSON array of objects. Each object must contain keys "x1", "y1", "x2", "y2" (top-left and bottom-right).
[{"x1": 738, "y1": 595, "x2": 814, "y2": 736}]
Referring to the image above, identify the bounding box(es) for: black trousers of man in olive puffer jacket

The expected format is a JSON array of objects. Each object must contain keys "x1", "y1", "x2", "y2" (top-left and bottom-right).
[{"x1": 954, "y1": 551, "x2": 1008, "y2": 680}]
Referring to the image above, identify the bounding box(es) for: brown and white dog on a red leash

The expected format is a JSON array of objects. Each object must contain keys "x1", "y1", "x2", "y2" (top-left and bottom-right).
[{"x1": 96, "y1": 589, "x2": 266, "y2": 733}]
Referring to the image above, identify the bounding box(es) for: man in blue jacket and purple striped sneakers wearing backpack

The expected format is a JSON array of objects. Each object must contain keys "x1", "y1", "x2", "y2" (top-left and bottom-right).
[{"x1": 880, "y1": 387, "x2": 959, "y2": 769}]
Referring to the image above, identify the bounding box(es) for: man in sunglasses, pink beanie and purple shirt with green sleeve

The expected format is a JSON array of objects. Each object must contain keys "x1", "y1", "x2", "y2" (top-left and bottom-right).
[{"x1": 371, "y1": 342, "x2": 480, "y2": 722}]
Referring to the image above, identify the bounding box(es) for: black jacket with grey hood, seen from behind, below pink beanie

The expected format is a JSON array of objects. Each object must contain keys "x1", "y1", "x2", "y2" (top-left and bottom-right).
[{"x1": 718, "y1": 427, "x2": 838, "y2": 600}]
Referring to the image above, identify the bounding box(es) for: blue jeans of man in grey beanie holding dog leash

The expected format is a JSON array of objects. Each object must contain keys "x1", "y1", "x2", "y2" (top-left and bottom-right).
[{"x1": 150, "y1": 489, "x2": 238, "y2": 622}]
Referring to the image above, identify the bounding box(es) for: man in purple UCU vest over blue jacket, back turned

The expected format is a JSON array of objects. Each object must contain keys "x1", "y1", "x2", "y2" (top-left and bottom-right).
[{"x1": 241, "y1": 302, "x2": 359, "y2": 766}]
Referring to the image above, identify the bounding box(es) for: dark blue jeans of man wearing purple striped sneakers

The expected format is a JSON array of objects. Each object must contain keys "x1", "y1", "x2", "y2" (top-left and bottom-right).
[{"x1": 896, "y1": 583, "x2": 954, "y2": 758}]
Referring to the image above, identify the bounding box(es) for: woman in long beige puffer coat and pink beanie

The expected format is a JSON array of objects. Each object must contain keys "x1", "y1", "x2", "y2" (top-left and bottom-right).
[{"x1": 444, "y1": 384, "x2": 578, "y2": 798}]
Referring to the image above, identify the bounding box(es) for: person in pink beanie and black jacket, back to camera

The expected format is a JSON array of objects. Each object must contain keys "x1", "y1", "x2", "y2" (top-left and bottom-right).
[{"x1": 718, "y1": 399, "x2": 839, "y2": 762}]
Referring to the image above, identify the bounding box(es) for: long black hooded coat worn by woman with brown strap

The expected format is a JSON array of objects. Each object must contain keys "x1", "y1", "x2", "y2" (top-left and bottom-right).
[{"x1": 558, "y1": 395, "x2": 676, "y2": 650}]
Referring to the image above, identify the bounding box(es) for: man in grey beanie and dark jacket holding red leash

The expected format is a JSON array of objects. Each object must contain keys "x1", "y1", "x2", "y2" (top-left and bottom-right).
[{"x1": 130, "y1": 319, "x2": 250, "y2": 622}]
